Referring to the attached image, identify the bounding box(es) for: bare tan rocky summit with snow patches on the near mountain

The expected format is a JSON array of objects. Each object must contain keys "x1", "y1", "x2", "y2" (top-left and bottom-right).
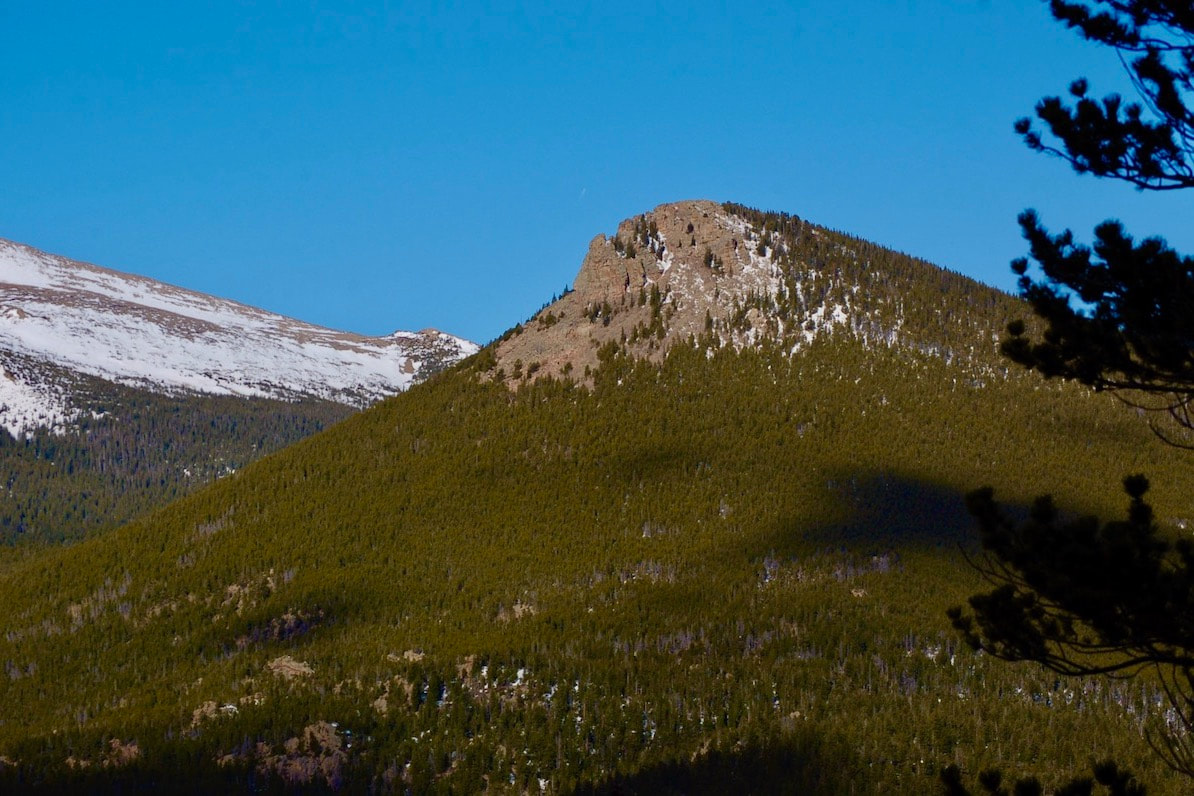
[{"x1": 494, "y1": 200, "x2": 903, "y2": 378}]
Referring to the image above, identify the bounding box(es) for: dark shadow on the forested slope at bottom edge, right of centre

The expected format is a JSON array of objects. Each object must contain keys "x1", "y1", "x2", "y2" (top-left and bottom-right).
[{"x1": 574, "y1": 729, "x2": 868, "y2": 796}]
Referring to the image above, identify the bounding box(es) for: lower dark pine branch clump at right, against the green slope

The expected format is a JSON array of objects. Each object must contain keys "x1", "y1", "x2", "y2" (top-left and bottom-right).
[{"x1": 948, "y1": 475, "x2": 1194, "y2": 776}]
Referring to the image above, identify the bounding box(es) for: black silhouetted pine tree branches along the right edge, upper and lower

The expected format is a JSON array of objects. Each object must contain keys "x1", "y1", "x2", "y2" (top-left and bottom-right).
[{"x1": 949, "y1": 0, "x2": 1194, "y2": 777}]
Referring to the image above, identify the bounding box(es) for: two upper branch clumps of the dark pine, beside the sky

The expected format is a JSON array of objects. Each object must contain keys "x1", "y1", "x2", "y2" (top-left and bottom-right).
[{"x1": 1003, "y1": 0, "x2": 1194, "y2": 442}]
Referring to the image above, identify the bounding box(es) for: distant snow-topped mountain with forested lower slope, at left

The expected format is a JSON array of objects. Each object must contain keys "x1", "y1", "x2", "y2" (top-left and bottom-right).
[{"x1": 0, "y1": 240, "x2": 476, "y2": 545}]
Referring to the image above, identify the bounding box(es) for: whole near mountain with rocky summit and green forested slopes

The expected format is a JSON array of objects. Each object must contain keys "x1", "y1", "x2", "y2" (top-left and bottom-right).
[{"x1": 0, "y1": 202, "x2": 1194, "y2": 794}]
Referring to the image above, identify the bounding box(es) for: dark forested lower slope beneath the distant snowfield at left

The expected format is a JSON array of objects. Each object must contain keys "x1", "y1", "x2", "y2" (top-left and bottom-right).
[{"x1": 0, "y1": 360, "x2": 351, "y2": 555}]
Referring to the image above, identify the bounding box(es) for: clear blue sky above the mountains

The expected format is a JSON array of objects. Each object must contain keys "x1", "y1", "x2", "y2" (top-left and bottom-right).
[{"x1": 0, "y1": 0, "x2": 1194, "y2": 341}]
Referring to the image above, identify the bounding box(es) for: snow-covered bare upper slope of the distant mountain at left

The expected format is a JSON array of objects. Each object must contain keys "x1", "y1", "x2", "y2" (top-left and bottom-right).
[{"x1": 0, "y1": 239, "x2": 478, "y2": 432}]
